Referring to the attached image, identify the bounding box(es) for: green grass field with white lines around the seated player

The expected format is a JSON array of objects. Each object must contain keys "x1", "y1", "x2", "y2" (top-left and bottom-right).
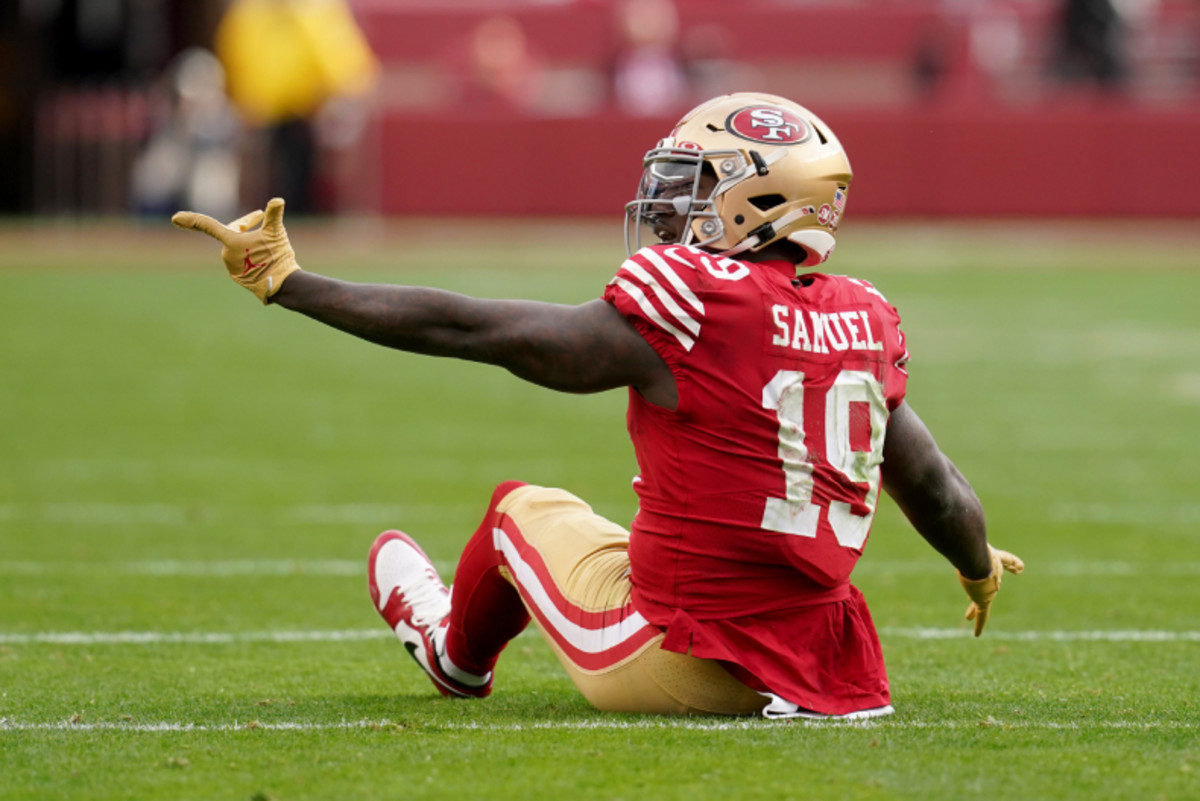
[{"x1": 0, "y1": 222, "x2": 1200, "y2": 801}]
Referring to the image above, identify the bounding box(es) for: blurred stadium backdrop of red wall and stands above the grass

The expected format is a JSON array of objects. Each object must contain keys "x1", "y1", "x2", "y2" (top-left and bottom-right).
[{"x1": 0, "y1": 0, "x2": 1200, "y2": 219}]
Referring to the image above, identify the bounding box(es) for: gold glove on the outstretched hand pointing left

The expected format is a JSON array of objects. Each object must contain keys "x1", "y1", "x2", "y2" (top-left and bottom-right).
[{"x1": 170, "y1": 198, "x2": 300, "y2": 303}]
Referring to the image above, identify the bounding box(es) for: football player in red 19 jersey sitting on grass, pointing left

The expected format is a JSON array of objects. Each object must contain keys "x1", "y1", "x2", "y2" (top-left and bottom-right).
[{"x1": 173, "y1": 94, "x2": 1024, "y2": 718}]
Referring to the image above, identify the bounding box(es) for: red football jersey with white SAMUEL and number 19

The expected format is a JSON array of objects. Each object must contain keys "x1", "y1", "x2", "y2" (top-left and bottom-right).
[{"x1": 604, "y1": 245, "x2": 907, "y2": 715}]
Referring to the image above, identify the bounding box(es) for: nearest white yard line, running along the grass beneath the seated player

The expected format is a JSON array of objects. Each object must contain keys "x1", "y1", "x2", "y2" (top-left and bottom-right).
[{"x1": 0, "y1": 717, "x2": 1200, "y2": 734}]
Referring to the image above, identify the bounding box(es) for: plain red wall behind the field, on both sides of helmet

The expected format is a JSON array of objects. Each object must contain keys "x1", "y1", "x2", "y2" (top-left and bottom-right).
[{"x1": 380, "y1": 104, "x2": 1200, "y2": 217}]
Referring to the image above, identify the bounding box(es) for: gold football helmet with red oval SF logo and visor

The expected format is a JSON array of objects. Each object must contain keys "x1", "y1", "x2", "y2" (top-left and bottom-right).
[{"x1": 625, "y1": 92, "x2": 853, "y2": 267}]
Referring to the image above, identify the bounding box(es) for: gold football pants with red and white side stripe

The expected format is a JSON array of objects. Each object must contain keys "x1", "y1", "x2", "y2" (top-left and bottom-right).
[{"x1": 476, "y1": 484, "x2": 766, "y2": 715}]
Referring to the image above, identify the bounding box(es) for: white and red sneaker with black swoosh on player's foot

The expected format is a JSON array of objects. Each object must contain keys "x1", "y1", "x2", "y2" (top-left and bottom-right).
[{"x1": 367, "y1": 531, "x2": 492, "y2": 698}]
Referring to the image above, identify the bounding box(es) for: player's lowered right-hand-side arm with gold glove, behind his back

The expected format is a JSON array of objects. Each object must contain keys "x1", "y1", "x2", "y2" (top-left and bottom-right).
[{"x1": 882, "y1": 403, "x2": 1025, "y2": 637}]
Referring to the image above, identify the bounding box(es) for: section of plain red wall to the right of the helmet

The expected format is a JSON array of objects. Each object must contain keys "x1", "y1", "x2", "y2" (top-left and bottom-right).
[{"x1": 830, "y1": 104, "x2": 1200, "y2": 217}]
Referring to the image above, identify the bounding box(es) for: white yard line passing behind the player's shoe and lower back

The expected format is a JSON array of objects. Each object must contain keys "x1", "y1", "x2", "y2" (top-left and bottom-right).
[{"x1": 0, "y1": 626, "x2": 1200, "y2": 645}]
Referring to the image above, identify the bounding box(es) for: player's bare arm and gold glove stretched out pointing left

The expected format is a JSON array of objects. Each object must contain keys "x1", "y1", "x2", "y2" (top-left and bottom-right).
[{"x1": 172, "y1": 198, "x2": 678, "y2": 409}]
